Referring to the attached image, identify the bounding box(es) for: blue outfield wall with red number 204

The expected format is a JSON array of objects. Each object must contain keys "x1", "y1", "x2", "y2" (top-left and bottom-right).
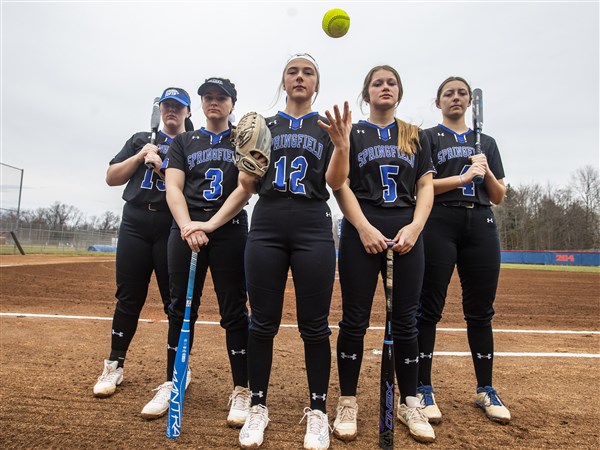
[{"x1": 501, "y1": 250, "x2": 600, "y2": 266}]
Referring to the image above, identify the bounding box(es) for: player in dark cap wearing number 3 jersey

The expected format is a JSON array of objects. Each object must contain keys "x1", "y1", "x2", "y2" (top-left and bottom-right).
[{"x1": 141, "y1": 78, "x2": 250, "y2": 427}]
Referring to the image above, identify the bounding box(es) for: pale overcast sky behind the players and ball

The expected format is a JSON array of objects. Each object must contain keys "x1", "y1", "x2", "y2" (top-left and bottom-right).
[{"x1": 1, "y1": 0, "x2": 599, "y2": 216}]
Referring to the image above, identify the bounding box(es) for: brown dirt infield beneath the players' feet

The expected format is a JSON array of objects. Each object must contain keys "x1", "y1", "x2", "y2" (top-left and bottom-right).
[{"x1": 0, "y1": 255, "x2": 600, "y2": 450}]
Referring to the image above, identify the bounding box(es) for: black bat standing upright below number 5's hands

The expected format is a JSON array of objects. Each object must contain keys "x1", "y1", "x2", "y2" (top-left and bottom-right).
[{"x1": 379, "y1": 246, "x2": 395, "y2": 450}]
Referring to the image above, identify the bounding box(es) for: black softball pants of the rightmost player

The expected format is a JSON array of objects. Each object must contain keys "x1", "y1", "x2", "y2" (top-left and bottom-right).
[{"x1": 418, "y1": 204, "x2": 500, "y2": 387}]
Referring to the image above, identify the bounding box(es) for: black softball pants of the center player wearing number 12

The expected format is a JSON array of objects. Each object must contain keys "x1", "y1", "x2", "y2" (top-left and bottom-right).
[{"x1": 246, "y1": 197, "x2": 335, "y2": 411}]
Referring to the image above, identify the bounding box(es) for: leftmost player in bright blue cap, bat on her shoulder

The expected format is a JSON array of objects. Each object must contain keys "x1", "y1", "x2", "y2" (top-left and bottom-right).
[{"x1": 94, "y1": 88, "x2": 193, "y2": 397}]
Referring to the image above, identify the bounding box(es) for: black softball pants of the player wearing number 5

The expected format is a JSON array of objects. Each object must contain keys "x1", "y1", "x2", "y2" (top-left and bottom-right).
[{"x1": 337, "y1": 204, "x2": 425, "y2": 401}]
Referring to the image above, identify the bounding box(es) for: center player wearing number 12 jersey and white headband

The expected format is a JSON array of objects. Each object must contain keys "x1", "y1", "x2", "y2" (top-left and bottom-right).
[{"x1": 239, "y1": 54, "x2": 335, "y2": 450}]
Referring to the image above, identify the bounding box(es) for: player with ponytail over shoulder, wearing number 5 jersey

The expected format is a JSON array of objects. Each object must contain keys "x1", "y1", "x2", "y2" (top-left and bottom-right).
[{"x1": 328, "y1": 65, "x2": 435, "y2": 442}]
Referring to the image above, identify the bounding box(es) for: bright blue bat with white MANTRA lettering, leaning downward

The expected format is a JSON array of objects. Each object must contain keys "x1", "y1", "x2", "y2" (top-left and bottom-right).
[{"x1": 167, "y1": 252, "x2": 198, "y2": 438}]
